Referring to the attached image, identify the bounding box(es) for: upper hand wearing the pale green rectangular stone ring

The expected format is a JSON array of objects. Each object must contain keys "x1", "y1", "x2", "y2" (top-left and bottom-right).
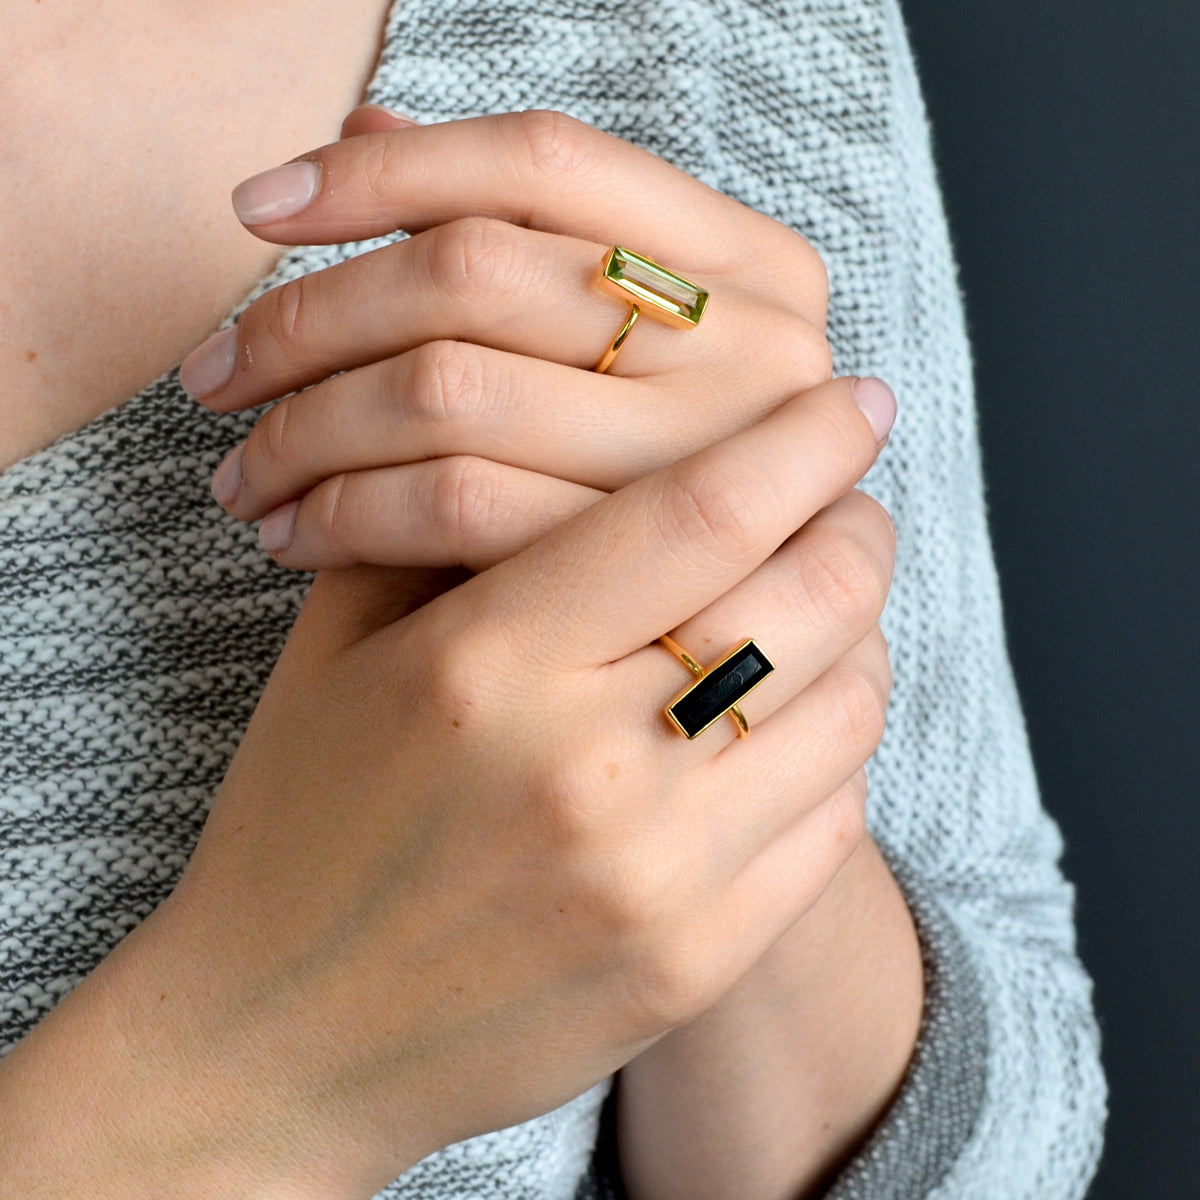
[{"x1": 184, "y1": 108, "x2": 830, "y2": 569}]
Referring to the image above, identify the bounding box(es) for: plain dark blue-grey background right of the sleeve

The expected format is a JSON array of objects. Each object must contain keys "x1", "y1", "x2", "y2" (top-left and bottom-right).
[{"x1": 902, "y1": 0, "x2": 1200, "y2": 1200}]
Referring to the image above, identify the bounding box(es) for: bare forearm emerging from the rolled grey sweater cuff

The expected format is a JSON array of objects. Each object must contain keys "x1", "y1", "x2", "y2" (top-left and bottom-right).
[{"x1": 617, "y1": 842, "x2": 923, "y2": 1200}]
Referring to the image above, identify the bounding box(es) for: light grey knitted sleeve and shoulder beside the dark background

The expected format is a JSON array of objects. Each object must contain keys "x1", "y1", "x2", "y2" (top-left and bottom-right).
[{"x1": 374, "y1": 0, "x2": 1104, "y2": 1200}]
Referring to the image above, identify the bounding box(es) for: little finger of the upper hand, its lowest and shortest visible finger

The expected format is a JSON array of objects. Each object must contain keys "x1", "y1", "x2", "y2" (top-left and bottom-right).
[{"x1": 259, "y1": 455, "x2": 604, "y2": 571}]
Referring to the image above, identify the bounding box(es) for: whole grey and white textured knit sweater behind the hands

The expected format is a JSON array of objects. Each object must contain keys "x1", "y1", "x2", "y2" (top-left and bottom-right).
[{"x1": 0, "y1": 0, "x2": 1104, "y2": 1200}]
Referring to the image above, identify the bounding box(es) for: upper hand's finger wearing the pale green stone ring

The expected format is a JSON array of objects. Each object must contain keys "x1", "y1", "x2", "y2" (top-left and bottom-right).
[{"x1": 180, "y1": 218, "x2": 806, "y2": 412}]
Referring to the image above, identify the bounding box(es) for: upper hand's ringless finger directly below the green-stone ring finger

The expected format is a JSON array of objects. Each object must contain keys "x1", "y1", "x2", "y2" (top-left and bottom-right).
[{"x1": 214, "y1": 342, "x2": 782, "y2": 521}]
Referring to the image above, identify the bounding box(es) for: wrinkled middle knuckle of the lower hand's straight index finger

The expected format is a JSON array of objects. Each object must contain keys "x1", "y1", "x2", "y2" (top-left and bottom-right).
[{"x1": 661, "y1": 463, "x2": 760, "y2": 564}]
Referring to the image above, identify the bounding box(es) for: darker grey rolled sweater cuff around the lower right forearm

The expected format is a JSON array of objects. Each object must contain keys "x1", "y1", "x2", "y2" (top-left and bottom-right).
[{"x1": 576, "y1": 872, "x2": 988, "y2": 1200}]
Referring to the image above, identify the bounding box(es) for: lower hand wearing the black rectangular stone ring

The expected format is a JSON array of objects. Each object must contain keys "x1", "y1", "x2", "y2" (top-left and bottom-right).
[{"x1": 0, "y1": 380, "x2": 892, "y2": 1198}]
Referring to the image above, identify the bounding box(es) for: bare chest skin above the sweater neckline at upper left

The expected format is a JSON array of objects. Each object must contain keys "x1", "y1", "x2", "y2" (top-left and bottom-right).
[{"x1": 0, "y1": 0, "x2": 386, "y2": 467}]
